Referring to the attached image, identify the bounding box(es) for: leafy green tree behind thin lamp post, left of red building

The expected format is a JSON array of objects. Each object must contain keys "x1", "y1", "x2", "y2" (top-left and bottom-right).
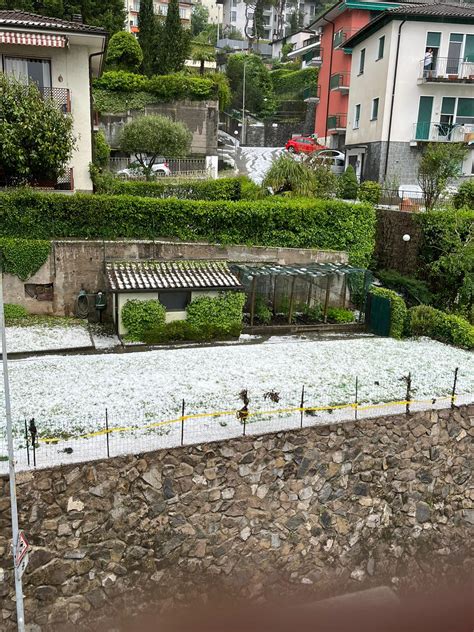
[{"x1": 226, "y1": 53, "x2": 276, "y2": 118}]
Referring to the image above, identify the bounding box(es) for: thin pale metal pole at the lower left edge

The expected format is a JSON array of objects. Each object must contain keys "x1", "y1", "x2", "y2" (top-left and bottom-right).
[{"x1": 0, "y1": 253, "x2": 25, "y2": 632}]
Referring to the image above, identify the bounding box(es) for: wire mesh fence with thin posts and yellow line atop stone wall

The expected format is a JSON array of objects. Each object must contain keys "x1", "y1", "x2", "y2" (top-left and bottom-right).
[{"x1": 0, "y1": 369, "x2": 466, "y2": 472}]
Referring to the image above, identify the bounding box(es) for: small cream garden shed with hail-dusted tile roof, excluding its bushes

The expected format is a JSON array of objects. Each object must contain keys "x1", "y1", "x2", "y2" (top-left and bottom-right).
[{"x1": 106, "y1": 260, "x2": 243, "y2": 335}]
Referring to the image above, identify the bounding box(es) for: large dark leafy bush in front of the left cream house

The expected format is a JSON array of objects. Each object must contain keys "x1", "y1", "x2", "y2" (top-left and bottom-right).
[{"x1": 0, "y1": 74, "x2": 76, "y2": 184}]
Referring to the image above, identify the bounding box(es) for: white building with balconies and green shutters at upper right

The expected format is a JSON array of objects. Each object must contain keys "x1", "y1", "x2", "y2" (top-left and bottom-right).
[{"x1": 345, "y1": 4, "x2": 474, "y2": 184}]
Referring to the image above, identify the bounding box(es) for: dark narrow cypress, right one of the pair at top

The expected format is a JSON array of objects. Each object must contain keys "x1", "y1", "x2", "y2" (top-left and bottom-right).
[{"x1": 156, "y1": 0, "x2": 191, "y2": 75}]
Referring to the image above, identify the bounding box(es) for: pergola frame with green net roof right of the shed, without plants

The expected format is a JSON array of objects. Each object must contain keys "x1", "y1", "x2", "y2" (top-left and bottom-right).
[{"x1": 231, "y1": 263, "x2": 372, "y2": 326}]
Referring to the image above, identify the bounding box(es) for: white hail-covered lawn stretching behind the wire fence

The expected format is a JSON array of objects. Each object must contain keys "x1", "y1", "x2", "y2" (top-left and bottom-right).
[{"x1": 0, "y1": 338, "x2": 474, "y2": 439}]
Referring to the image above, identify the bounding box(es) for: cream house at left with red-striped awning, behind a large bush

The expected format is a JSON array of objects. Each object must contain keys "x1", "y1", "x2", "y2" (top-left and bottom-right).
[{"x1": 0, "y1": 11, "x2": 107, "y2": 191}]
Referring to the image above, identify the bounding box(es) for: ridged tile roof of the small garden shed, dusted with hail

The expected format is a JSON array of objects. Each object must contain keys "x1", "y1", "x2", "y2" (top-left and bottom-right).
[{"x1": 106, "y1": 261, "x2": 242, "y2": 292}]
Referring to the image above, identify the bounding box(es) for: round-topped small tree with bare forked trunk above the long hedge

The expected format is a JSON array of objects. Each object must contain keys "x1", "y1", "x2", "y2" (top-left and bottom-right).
[{"x1": 120, "y1": 116, "x2": 192, "y2": 180}]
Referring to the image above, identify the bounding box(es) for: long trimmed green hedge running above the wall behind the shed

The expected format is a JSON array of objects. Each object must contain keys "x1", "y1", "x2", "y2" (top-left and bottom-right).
[{"x1": 0, "y1": 189, "x2": 375, "y2": 266}]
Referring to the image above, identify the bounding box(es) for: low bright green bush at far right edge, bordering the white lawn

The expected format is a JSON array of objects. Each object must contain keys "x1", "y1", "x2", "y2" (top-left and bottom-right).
[{"x1": 408, "y1": 305, "x2": 474, "y2": 349}]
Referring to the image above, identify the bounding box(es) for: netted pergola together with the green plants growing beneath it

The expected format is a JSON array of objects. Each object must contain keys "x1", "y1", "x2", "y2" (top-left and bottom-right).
[{"x1": 231, "y1": 263, "x2": 372, "y2": 326}]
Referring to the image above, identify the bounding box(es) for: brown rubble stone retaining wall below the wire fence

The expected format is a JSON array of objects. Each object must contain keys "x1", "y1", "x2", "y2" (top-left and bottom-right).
[{"x1": 0, "y1": 405, "x2": 474, "y2": 632}]
